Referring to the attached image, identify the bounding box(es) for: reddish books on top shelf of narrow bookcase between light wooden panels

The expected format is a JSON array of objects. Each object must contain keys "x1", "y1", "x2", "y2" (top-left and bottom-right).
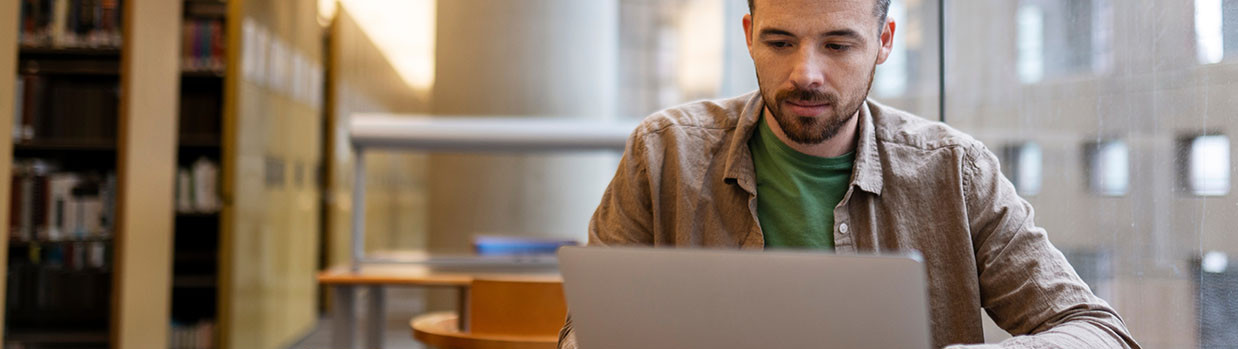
[{"x1": 181, "y1": 19, "x2": 227, "y2": 72}]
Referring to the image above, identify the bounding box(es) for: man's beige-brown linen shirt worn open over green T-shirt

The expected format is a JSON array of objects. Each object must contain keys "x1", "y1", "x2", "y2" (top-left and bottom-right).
[{"x1": 560, "y1": 92, "x2": 1139, "y2": 349}]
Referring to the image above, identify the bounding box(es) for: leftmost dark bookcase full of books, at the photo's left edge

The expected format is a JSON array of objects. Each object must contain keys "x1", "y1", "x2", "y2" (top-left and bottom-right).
[{"x1": 4, "y1": 1, "x2": 121, "y2": 348}]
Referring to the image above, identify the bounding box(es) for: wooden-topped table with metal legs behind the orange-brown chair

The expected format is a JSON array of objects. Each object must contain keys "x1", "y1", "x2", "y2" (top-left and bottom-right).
[{"x1": 318, "y1": 264, "x2": 560, "y2": 348}]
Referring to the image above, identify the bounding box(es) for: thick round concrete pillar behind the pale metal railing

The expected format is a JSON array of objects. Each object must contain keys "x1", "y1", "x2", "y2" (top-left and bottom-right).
[{"x1": 426, "y1": 0, "x2": 619, "y2": 252}]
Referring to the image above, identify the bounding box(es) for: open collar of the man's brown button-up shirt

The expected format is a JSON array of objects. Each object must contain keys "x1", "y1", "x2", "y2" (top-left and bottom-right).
[{"x1": 723, "y1": 92, "x2": 884, "y2": 196}]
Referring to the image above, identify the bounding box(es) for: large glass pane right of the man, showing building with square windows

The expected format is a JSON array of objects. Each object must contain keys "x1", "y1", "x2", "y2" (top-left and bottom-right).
[{"x1": 946, "y1": 0, "x2": 1238, "y2": 348}]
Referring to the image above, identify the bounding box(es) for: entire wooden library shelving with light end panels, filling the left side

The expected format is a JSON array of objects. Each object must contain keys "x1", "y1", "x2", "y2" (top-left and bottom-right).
[{"x1": 0, "y1": 0, "x2": 323, "y2": 349}]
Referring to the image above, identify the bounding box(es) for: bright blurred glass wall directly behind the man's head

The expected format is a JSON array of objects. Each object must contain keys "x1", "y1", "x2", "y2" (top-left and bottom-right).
[{"x1": 619, "y1": 0, "x2": 940, "y2": 120}]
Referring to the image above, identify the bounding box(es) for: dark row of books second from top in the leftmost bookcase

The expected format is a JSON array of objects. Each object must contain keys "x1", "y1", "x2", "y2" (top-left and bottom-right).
[{"x1": 12, "y1": 73, "x2": 120, "y2": 141}]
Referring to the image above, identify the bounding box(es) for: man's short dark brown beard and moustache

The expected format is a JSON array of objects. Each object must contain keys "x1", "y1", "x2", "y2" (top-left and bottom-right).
[{"x1": 756, "y1": 64, "x2": 877, "y2": 145}]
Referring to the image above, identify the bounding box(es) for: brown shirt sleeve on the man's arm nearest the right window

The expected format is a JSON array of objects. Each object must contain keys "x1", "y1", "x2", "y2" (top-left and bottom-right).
[{"x1": 950, "y1": 142, "x2": 1140, "y2": 348}]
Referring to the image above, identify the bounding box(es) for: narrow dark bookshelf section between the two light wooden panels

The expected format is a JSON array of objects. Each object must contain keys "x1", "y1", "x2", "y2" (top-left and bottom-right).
[{"x1": 170, "y1": 0, "x2": 228, "y2": 349}]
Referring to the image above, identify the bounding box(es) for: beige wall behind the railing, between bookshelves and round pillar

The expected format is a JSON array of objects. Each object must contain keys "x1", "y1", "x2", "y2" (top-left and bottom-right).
[{"x1": 326, "y1": 9, "x2": 430, "y2": 265}]
